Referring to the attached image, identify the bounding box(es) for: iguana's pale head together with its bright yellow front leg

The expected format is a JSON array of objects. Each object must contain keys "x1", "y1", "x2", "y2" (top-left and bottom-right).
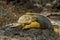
[{"x1": 12, "y1": 15, "x2": 40, "y2": 29}]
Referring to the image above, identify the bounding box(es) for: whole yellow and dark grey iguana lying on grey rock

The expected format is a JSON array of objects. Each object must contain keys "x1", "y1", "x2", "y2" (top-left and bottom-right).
[{"x1": 12, "y1": 13, "x2": 59, "y2": 34}]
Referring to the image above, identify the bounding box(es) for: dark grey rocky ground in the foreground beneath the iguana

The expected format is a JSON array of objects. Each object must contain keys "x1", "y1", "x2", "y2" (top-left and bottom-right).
[{"x1": 0, "y1": 26, "x2": 60, "y2": 40}]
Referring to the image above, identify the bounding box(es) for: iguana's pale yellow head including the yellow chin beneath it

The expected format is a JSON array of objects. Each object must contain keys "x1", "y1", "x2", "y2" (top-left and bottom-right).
[{"x1": 10, "y1": 14, "x2": 36, "y2": 27}]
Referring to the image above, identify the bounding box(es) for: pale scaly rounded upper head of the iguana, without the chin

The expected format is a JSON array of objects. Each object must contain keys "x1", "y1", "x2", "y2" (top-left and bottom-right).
[{"x1": 18, "y1": 15, "x2": 36, "y2": 23}]
